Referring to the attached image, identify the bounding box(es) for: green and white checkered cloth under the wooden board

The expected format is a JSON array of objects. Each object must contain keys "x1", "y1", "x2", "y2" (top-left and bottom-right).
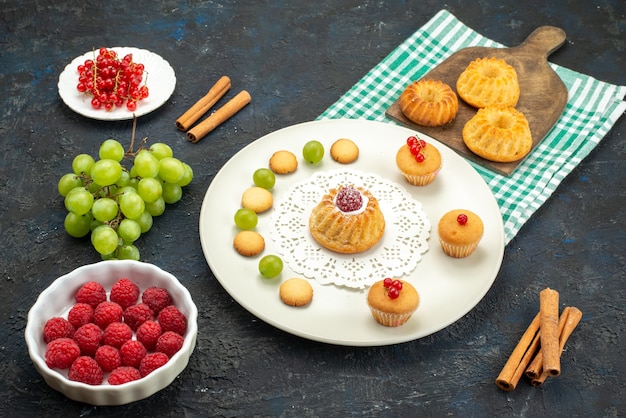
[{"x1": 318, "y1": 10, "x2": 626, "y2": 244}]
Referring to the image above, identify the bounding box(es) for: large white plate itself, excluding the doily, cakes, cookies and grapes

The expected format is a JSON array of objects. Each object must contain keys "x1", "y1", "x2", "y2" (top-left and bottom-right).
[{"x1": 199, "y1": 119, "x2": 504, "y2": 346}]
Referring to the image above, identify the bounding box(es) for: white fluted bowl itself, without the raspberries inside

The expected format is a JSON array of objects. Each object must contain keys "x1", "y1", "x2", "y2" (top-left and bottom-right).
[{"x1": 24, "y1": 260, "x2": 198, "y2": 405}]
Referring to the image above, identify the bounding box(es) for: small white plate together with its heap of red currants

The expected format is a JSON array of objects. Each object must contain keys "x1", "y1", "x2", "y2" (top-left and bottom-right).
[{"x1": 58, "y1": 47, "x2": 176, "y2": 120}]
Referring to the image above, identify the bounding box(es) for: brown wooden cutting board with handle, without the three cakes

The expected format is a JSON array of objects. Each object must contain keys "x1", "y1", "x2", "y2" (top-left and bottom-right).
[{"x1": 385, "y1": 26, "x2": 567, "y2": 176}]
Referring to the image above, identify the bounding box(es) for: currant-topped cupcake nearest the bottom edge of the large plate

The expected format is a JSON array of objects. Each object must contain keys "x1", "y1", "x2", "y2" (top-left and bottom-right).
[{"x1": 367, "y1": 278, "x2": 419, "y2": 327}]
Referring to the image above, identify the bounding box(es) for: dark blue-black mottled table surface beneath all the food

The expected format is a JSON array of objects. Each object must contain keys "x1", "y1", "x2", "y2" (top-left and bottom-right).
[{"x1": 0, "y1": 0, "x2": 626, "y2": 417}]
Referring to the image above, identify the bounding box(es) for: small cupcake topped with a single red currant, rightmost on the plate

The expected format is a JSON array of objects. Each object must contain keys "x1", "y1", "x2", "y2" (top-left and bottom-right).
[{"x1": 438, "y1": 209, "x2": 484, "y2": 258}]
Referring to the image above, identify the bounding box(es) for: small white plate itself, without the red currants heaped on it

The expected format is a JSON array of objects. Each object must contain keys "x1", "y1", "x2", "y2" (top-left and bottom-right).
[{"x1": 58, "y1": 47, "x2": 176, "y2": 120}]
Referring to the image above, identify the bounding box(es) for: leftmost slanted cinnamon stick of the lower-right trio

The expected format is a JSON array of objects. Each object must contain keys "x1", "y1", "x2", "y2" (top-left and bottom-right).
[{"x1": 496, "y1": 313, "x2": 541, "y2": 392}]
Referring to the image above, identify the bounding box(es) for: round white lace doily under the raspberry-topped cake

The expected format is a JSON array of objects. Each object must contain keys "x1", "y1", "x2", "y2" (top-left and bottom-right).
[{"x1": 270, "y1": 170, "x2": 431, "y2": 289}]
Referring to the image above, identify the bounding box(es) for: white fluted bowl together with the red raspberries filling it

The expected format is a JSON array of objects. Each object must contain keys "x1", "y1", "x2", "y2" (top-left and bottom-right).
[{"x1": 25, "y1": 260, "x2": 198, "y2": 405}]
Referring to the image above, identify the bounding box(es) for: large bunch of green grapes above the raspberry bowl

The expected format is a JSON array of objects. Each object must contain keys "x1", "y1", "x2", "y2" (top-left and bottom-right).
[{"x1": 57, "y1": 139, "x2": 193, "y2": 260}]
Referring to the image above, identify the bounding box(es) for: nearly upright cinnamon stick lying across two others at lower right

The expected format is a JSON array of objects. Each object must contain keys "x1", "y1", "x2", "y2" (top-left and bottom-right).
[{"x1": 539, "y1": 288, "x2": 561, "y2": 376}]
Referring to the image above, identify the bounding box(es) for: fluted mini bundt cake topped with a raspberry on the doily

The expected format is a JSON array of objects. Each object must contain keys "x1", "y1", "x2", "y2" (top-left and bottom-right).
[{"x1": 309, "y1": 185, "x2": 385, "y2": 254}]
